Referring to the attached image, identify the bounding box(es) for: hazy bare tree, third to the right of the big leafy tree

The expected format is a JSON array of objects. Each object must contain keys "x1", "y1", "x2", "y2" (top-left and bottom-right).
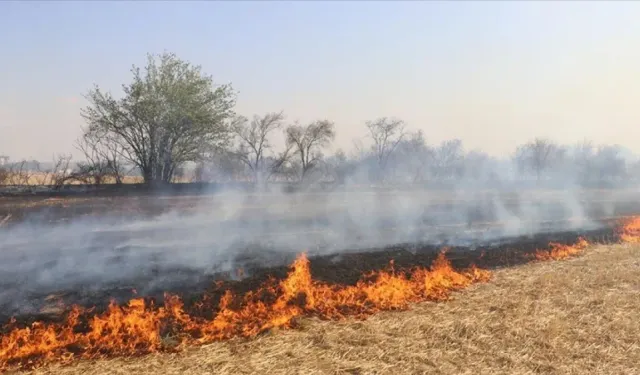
[{"x1": 366, "y1": 117, "x2": 405, "y2": 179}]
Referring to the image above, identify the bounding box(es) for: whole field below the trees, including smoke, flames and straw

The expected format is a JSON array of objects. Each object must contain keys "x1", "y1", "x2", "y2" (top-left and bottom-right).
[{"x1": 0, "y1": 191, "x2": 640, "y2": 374}]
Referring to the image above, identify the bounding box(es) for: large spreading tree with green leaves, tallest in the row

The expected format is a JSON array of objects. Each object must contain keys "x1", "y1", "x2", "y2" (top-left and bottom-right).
[{"x1": 82, "y1": 52, "x2": 236, "y2": 184}]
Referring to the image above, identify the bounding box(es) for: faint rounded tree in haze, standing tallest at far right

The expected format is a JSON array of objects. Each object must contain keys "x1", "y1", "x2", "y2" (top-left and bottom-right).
[{"x1": 515, "y1": 138, "x2": 566, "y2": 181}]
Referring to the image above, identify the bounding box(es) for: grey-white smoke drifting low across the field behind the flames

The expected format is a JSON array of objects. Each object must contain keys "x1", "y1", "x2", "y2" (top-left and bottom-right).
[{"x1": 0, "y1": 142, "x2": 636, "y2": 313}]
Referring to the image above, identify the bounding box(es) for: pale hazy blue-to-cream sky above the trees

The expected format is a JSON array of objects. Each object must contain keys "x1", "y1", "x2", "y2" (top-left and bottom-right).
[{"x1": 0, "y1": 1, "x2": 640, "y2": 161}]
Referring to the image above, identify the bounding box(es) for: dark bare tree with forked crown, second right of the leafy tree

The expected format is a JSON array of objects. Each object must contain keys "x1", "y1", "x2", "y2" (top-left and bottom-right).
[{"x1": 285, "y1": 120, "x2": 336, "y2": 180}]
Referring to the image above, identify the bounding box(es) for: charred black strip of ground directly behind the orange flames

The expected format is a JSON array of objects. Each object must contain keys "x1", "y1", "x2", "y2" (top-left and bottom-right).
[{"x1": 0, "y1": 221, "x2": 618, "y2": 325}]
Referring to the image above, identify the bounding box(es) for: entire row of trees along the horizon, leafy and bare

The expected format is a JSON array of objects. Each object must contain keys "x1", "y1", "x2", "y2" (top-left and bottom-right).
[{"x1": 0, "y1": 52, "x2": 640, "y2": 186}]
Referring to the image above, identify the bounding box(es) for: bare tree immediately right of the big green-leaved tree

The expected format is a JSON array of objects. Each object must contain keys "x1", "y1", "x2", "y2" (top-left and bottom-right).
[{"x1": 231, "y1": 112, "x2": 292, "y2": 185}]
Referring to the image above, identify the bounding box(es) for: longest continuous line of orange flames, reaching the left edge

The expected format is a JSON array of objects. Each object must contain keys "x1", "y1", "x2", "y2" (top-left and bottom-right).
[{"x1": 0, "y1": 253, "x2": 491, "y2": 370}]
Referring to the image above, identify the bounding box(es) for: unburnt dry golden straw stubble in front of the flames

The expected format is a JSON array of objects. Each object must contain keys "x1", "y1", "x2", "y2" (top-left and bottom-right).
[{"x1": 22, "y1": 245, "x2": 640, "y2": 375}]
